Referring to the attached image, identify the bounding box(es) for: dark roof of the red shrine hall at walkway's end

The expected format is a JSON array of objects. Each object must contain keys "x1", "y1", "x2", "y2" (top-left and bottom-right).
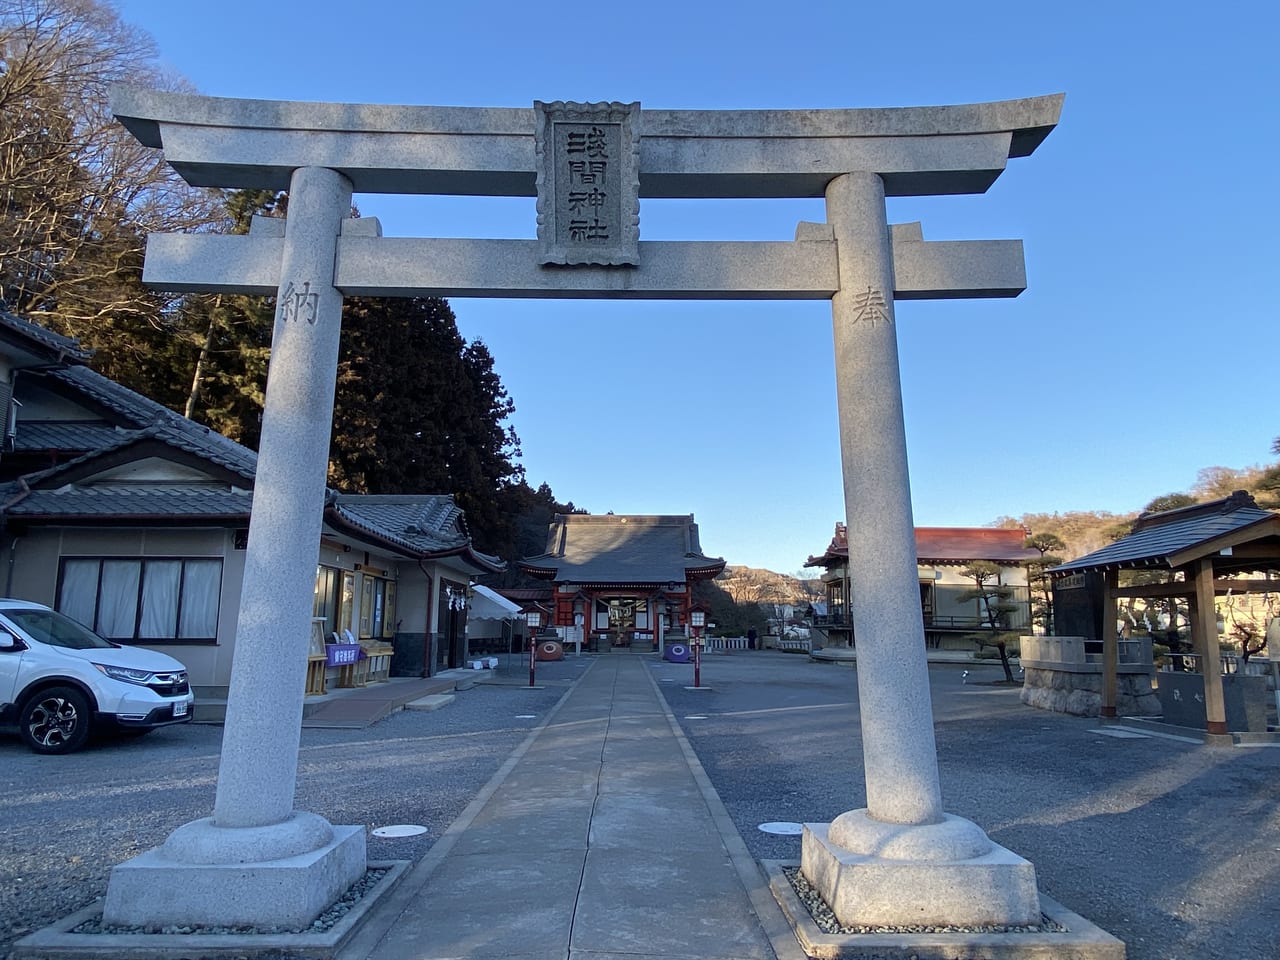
[{"x1": 521, "y1": 513, "x2": 724, "y2": 584}]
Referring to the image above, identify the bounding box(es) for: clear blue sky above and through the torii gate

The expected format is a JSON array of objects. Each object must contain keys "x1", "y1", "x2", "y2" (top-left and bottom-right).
[{"x1": 112, "y1": 0, "x2": 1280, "y2": 572}]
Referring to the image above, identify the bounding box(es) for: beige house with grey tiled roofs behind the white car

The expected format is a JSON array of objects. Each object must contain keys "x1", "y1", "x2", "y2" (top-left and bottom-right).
[{"x1": 0, "y1": 307, "x2": 504, "y2": 696}]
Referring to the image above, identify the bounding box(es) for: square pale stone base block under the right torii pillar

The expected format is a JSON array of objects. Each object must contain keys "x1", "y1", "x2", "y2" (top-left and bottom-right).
[{"x1": 800, "y1": 812, "x2": 1041, "y2": 927}]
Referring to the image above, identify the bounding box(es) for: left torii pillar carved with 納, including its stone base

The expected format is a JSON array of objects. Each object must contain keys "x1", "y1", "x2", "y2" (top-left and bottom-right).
[{"x1": 102, "y1": 166, "x2": 366, "y2": 927}]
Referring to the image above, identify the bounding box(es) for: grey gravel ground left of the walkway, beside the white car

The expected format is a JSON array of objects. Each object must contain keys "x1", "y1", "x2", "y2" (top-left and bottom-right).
[{"x1": 0, "y1": 658, "x2": 589, "y2": 959}]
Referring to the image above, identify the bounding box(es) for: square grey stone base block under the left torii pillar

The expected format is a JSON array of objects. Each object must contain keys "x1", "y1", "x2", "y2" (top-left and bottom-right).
[{"x1": 102, "y1": 827, "x2": 366, "y2": 928}]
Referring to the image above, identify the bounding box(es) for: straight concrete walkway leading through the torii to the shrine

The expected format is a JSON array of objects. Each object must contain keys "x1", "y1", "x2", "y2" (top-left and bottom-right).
[{"x1": 340, "y1": 654, "x2": 804, "y2": 960}]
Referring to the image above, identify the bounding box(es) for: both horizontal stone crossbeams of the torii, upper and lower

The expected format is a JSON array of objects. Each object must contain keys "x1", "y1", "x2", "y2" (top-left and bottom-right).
[{"x1": 111, "y1": 87, "x2": 1062, "y2": 300}]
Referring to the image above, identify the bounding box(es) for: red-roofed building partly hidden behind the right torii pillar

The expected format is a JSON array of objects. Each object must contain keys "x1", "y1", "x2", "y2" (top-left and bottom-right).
[{"x1": 805, "y1": 524, "x2": 1039, "y2": 650}]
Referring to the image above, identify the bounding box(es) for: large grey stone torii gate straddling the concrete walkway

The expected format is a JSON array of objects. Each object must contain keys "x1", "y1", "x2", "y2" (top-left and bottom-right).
[{"x1": 104, "y1": 88, "x2": 1062, "y2": 925}]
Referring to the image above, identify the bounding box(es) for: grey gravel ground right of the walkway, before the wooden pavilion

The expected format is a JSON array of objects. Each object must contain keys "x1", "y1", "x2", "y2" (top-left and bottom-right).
[{"x1": 653, "y1": 652, "x2": 1280, "y2": 960}]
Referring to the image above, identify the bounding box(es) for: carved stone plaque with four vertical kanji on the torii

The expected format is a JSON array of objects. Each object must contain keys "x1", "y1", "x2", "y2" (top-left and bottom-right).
[{"x1": 534, "y1": 100, "x2": 640, "y2": 266}]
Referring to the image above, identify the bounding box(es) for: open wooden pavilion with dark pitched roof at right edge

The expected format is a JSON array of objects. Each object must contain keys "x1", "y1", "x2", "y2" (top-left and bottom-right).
[{"x1": 1048, "y1": 490, "x2": 1280, "y2": 735}]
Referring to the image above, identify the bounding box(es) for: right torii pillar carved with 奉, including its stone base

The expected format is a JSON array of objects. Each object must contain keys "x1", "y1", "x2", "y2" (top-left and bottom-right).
[{"x1": 800, "y1": 173, "x2": 1041, "y2": 925}]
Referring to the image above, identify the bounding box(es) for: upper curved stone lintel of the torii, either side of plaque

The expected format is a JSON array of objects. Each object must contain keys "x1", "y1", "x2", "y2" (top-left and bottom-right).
[{"x1": 111, "y1": 86, "x2": 1064, "y2": 198}]
